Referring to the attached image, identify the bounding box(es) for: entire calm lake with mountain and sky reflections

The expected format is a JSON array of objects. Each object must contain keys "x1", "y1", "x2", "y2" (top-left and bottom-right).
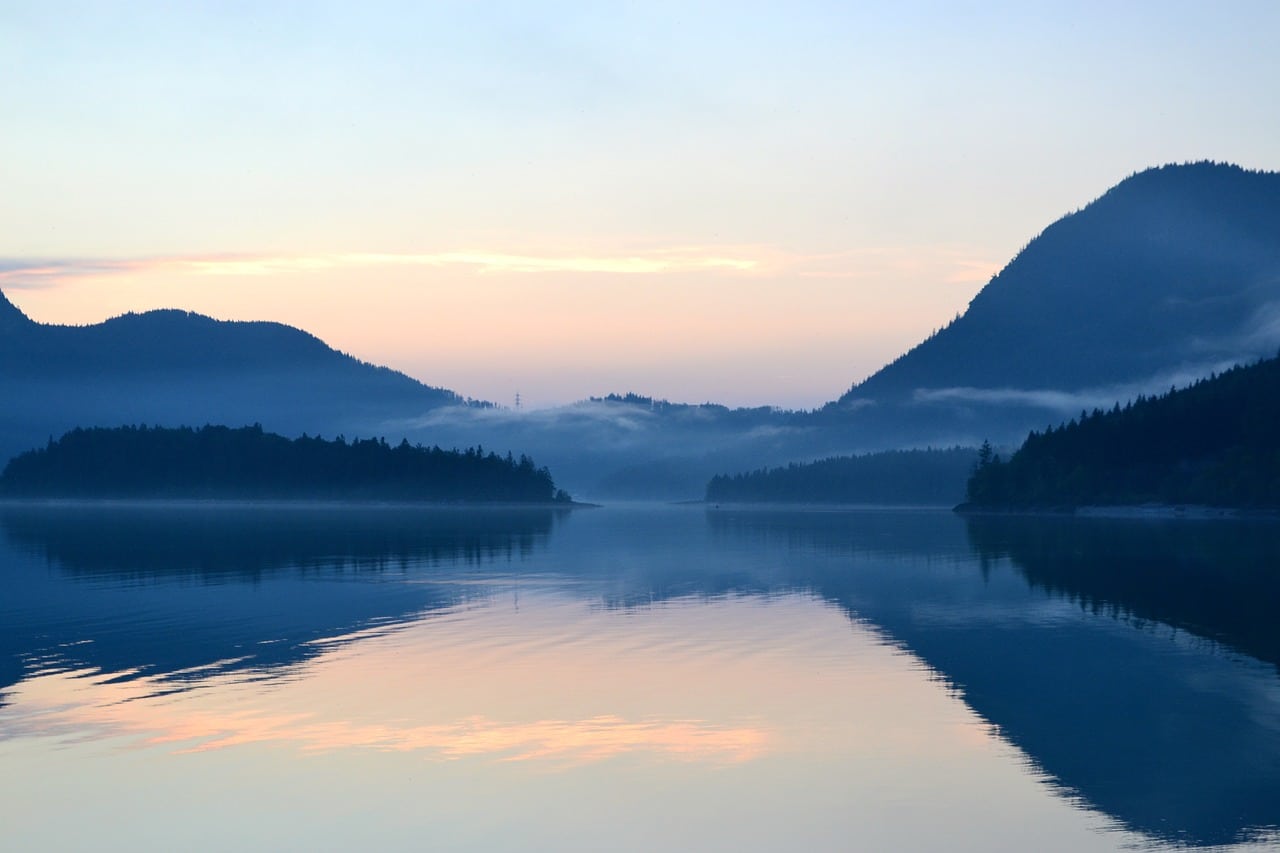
[{"x1": 0, "y1": 505, "x2": 1280, "y2": 852}]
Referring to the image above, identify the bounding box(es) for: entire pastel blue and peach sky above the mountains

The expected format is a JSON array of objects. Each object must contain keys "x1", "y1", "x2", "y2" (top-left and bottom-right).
[{"x1": 0, "y1": 0, "x2": 1280, "y2": 407}]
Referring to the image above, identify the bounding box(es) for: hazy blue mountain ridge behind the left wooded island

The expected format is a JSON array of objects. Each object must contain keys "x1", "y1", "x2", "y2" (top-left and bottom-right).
[{"x1": 0, "y1": 293, "x2": 465, "y2": 459}]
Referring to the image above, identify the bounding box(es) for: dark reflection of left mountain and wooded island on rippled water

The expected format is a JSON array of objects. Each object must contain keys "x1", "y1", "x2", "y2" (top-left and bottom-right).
[{"x1": 0, "y1": 503, "x2": 556, "y2": 701}]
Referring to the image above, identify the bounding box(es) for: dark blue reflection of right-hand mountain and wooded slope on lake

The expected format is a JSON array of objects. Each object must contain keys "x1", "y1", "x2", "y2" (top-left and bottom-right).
[{"x1": 708, "y1": 512, "x2": 1280, "y2": 845}]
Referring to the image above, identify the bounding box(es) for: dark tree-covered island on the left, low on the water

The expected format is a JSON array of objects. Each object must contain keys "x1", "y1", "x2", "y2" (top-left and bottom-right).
[{"x1": 0, "y1": 425, "x2": 570, "y2": 503}]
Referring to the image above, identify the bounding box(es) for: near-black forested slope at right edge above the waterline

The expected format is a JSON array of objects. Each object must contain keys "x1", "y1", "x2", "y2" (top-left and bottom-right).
[{"x1": 965, "y1": 350, "x2": 1280, "y2": 510}]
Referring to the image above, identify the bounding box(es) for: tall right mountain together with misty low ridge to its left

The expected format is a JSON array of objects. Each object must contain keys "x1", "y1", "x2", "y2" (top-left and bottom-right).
[{"x1": 396, "y1": 163, "x2": 1280, "y2": 498}]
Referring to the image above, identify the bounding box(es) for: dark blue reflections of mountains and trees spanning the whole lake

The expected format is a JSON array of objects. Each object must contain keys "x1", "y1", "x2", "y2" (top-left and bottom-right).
[{"x1": 0, "y1": 507, "x2": 1280, "y2": 844}]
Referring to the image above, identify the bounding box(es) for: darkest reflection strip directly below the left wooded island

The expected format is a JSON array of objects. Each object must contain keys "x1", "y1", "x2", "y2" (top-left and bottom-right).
[{"x1": 0, "y1": 503, "x2": 559, "y2": 576}]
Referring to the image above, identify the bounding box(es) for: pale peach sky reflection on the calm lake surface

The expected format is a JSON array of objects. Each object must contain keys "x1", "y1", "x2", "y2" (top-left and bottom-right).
[{"x1": 0, "y1": 590, "x2": 1131, "y2": 850}]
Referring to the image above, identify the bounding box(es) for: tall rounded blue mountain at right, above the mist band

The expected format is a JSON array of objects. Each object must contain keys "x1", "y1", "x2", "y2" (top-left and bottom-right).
[{"x1": 837, "y1": 163, "x2": 1280, "y2": 404}]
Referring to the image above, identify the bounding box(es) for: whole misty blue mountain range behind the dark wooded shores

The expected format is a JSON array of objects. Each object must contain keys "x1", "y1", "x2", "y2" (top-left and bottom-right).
[{"x1": 0, "y1": 163, "x2": 1280, "y2": 498}]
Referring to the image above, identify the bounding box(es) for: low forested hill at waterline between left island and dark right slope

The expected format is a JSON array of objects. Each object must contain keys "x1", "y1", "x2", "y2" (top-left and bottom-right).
[{"x1": 707, "y1": 447, "x2": 978, "y2": 506}]
